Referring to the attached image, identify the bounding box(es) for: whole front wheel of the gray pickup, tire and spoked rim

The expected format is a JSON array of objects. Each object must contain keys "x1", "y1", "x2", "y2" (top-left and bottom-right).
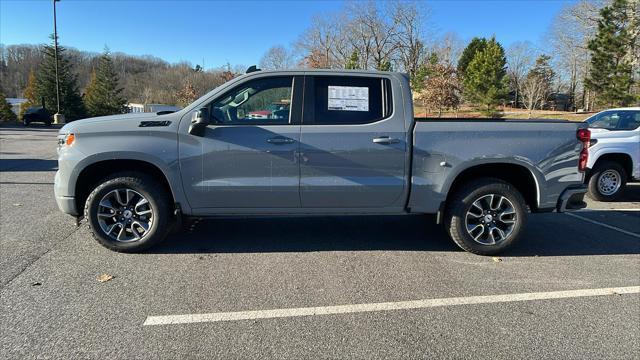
[{"x1": 84, "y1": 172, "x2": 171, "y2": 252}]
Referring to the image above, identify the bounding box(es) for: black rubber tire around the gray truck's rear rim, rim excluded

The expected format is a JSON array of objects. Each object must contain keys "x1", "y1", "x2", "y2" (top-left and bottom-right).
[{"x1": 447, "y1": 179, "x2": 528, "y2": 255}]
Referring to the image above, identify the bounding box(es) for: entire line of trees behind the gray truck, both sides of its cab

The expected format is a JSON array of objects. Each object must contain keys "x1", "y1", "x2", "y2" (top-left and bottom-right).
[{"x1": 0, "y1": 0, "x2": 640, "y2": 119}]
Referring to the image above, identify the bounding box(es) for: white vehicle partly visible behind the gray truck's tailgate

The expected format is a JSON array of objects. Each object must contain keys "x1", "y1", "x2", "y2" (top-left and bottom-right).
[{"x1": 585, "y1": 107, "x2": 640, "y2": 201}]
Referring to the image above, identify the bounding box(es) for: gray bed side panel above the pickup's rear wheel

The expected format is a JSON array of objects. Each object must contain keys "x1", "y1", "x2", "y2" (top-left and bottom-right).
[{"x1": 409, "y1": 121, "x2": 583, "y2": 213}]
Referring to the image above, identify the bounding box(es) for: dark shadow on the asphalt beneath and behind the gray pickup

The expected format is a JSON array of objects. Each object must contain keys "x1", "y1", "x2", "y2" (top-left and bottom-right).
[{"x1": 150, "y1": 214, "x2": 640, "y2": 257}]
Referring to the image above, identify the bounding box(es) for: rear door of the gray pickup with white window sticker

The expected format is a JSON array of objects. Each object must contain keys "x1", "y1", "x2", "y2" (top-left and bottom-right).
[{"x1": 299, "y1": 74, "x2": 407, "y2": 209}]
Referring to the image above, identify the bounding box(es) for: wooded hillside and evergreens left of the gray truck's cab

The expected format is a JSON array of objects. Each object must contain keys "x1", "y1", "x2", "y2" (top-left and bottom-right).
[{"x1": 0, "y1": 39, "x2": 242, "y2": 121}]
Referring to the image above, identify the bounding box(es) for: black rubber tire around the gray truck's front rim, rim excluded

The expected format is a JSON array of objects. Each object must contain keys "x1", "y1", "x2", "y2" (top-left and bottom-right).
[{"x1": 85, "y1": 176, "x2": 169, "y2": 252}]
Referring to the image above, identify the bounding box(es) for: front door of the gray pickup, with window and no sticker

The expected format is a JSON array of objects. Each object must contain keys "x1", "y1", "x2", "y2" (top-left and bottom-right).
[{"x1": 180, "y1": 76, "x2": 303, "y2": 213}]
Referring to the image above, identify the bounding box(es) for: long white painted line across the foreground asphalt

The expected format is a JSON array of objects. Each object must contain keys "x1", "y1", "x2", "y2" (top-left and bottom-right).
[{"x1": 143, "y1": 286, "x2": 640, "y2": 326}]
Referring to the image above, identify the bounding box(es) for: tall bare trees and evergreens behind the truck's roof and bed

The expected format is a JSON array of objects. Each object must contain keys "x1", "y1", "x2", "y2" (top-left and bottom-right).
[{"x1": 272, "y1": 0, "x2": 640, "y2": 114}]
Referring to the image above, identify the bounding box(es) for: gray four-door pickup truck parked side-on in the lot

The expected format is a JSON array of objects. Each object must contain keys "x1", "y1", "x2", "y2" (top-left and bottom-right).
[{"x1": 55, "y1": 70, "x2": 590, "y2": 255}]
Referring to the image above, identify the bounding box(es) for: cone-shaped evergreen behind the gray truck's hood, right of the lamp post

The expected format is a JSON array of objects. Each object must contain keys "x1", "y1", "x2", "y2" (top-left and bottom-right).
[{"x1": 84, "y1": 50, "x2": 127, "y2": 116}]
